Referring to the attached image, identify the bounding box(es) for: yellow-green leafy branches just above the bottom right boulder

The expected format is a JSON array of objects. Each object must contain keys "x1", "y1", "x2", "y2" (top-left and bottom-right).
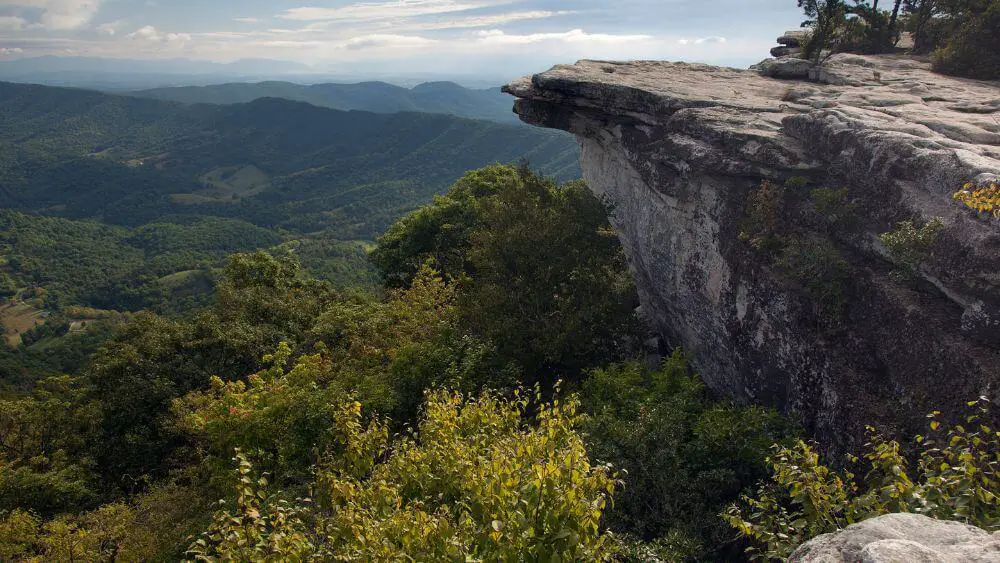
[{"x1": 724, "y1": 398, "x2": 1000, "y2": 559}]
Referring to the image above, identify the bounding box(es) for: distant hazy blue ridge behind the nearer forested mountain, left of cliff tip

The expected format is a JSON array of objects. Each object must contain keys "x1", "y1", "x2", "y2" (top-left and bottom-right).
[{"x1": 131, "y1": 82, "x2": 519, "y2": 123}]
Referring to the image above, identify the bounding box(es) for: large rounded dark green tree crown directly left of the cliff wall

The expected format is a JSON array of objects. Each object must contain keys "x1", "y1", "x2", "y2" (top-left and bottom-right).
[{"x1": 372, "y1": 166, "x2": 639, "y2": 382}]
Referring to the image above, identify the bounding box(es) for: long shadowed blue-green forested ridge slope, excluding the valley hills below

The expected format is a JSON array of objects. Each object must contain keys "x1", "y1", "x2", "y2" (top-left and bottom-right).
[{"x1": 0, "y1": 83, "x2": 579, "y2": 240}]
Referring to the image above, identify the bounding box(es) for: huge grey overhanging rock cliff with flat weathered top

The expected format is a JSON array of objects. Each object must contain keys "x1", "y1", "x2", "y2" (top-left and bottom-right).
[{"x1": 506, "y1": 55, "x2": 1000, "y2": 451}]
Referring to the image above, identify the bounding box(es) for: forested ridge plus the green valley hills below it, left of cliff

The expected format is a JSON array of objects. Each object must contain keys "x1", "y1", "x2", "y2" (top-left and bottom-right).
[{"x1": 0, "y1": 83, "x2": 579, "y2": 316}]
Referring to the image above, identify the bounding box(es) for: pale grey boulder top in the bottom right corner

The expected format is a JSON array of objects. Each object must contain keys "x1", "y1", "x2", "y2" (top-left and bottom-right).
[{"x1": 789, "y1": 514, "x2": 1000, "y2": 563}]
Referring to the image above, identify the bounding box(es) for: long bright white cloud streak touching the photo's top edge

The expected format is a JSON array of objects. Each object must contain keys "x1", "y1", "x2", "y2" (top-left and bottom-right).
[{"x1": 278, "y1": 0, "x2": 510, "y2": 21}]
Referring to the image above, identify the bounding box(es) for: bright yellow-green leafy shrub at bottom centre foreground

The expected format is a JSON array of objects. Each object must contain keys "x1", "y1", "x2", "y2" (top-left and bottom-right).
[{"x1": 188, "y1": 391, "x2": 616, "y2": 561}]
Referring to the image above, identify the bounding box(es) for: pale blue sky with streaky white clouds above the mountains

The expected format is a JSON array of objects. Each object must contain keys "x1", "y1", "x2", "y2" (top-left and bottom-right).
[{"x1": 0, "y1": 0, "x2": 802, "y2": 74}]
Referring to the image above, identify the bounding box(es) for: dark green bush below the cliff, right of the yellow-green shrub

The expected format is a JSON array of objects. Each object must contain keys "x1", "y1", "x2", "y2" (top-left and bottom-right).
[{"x1": 583, "y1": 351, "x2": 795, "y2": 560}]
